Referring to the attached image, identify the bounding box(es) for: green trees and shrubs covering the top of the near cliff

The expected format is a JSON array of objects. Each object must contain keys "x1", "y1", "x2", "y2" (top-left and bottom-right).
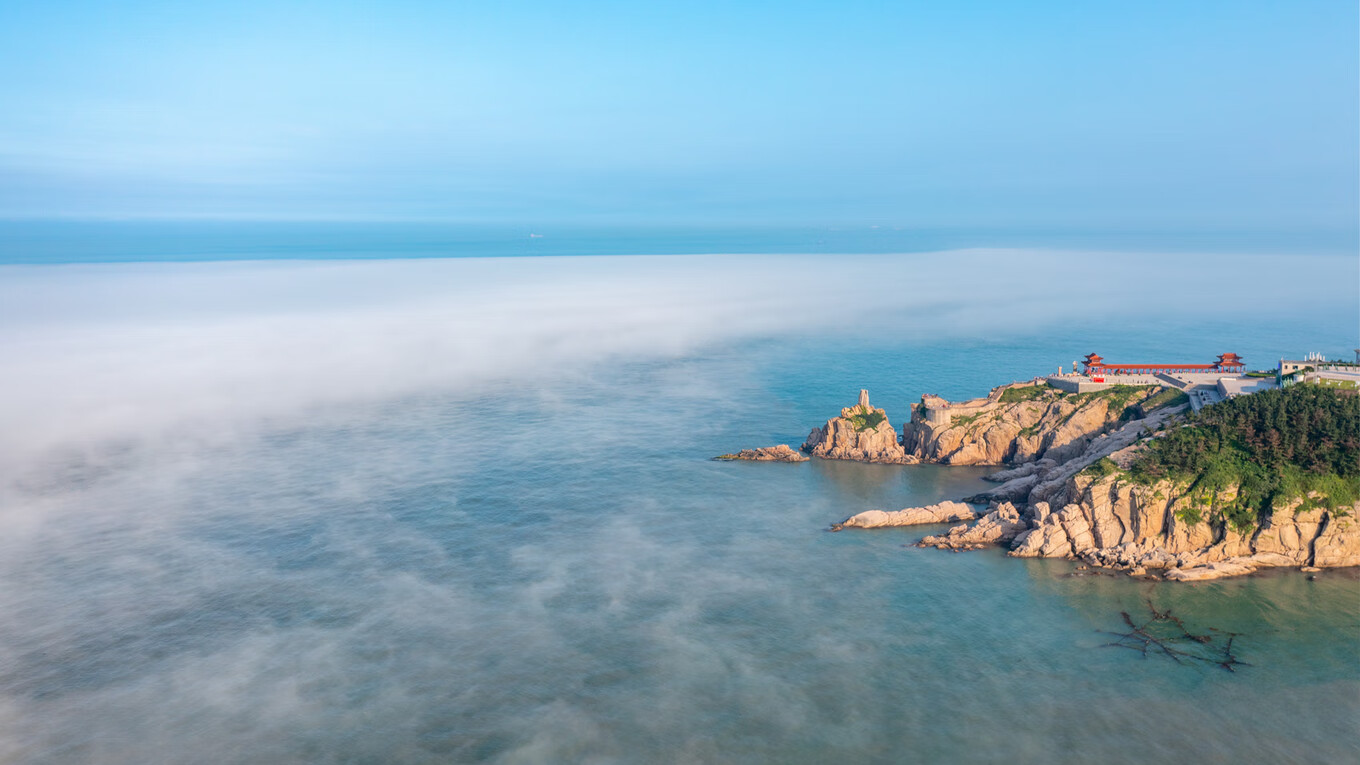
[{"x1": 1130, "y1": 385, "x2": 1360, "y2": 530}]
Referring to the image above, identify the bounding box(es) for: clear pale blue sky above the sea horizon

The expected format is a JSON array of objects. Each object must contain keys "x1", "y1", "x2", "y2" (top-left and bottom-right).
[{"x1": 0, "y1": 0, "x2": 1360, "y2": 229}]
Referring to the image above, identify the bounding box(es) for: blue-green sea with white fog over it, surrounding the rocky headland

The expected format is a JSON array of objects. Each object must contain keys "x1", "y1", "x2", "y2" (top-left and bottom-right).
[{"x1": 0, "y1": 228, "x2": 1360, "y2": 764}]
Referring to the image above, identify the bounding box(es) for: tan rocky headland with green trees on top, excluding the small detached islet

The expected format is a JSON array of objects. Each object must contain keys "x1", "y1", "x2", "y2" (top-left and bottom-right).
[{"x1": 832, "y1": 387, "x2": 1360, "y2": 581}]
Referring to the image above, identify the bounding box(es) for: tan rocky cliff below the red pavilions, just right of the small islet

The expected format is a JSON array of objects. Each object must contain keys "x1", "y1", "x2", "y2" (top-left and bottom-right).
[{"x1": 902, "y1": 383, "x2": 1160, "y2": 465}]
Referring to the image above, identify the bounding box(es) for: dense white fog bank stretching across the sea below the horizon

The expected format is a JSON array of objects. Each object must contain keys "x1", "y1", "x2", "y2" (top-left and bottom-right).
[{"x1": 0, "y1": 250, "x2": 1357, "y2": 472}]
